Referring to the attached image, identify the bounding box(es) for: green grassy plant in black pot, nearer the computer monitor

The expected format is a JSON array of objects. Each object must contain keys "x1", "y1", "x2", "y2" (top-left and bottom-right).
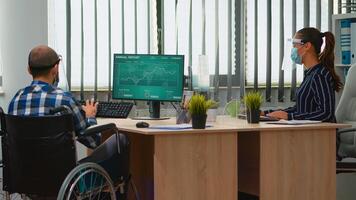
[{"x1": 188, "y1": 94, "x2": 213, "y2": 129}]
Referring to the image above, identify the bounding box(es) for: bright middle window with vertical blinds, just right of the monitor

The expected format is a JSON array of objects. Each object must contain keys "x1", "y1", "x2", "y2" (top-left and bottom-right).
[{"x1": 164, "y1": 0, "x2": 235, "y2": 74}]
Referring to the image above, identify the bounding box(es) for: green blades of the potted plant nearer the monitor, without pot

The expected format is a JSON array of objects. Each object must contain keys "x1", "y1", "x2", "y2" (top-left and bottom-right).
[{"x1": 188, "y1": 94, "x2": 213, "y2": 115}]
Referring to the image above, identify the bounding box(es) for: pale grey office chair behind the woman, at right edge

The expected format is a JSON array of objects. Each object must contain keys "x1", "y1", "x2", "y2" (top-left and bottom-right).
[{"x1": 335, "y1": 64, "x2": 356, "y2": 173}]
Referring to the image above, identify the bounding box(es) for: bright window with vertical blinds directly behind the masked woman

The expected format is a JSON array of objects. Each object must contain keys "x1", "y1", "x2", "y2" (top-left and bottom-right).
[{"x1": 246, "y1": 0, "x2": 328, "y2": 85}]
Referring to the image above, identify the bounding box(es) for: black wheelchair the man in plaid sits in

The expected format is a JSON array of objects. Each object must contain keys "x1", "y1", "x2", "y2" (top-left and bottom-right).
[{"x1": 0, "y1": 106, "x2": 139, "y2": 200}]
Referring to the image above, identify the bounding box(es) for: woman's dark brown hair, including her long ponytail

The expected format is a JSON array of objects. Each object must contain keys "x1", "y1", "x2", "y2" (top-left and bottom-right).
[{"x1": 297, "y1": 28, "x2": 343, "y2": 92}]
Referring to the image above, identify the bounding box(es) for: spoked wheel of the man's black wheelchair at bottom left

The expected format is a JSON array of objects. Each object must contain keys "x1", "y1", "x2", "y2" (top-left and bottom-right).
[{"x1": 57, "y1": 163, "x2": 116, "y2": 200}]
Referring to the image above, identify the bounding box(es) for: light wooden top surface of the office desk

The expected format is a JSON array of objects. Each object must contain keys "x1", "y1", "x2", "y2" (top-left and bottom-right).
[{"x1": 97, "y1": 116, "x2": 351, "y2": 135}]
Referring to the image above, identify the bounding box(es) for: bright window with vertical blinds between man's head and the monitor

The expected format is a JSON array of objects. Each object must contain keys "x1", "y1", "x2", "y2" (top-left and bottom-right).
[{"x1": 48, "y1": 0, "x2": 157, "y2": 90}]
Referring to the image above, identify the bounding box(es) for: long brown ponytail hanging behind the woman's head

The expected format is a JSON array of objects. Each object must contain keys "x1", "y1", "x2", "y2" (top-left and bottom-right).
[{"x1": 319, "y1": 32, "x2": 343, "y2": 92}]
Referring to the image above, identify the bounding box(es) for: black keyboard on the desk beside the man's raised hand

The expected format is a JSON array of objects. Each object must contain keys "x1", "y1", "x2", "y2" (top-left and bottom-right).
[{"x1": 80, "y1": 101, "x2": 133, "y2": 118}]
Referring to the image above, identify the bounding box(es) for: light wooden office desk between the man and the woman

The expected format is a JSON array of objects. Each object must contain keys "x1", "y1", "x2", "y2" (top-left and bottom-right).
[{"x1": 98, "y1": 116, "x2": 347, "y2": 200}]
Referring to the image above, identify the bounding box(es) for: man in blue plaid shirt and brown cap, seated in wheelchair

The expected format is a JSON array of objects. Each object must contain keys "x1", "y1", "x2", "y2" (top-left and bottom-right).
[{"x1": 8, "y1": 45, "x2": 129, "y2": 199}]
